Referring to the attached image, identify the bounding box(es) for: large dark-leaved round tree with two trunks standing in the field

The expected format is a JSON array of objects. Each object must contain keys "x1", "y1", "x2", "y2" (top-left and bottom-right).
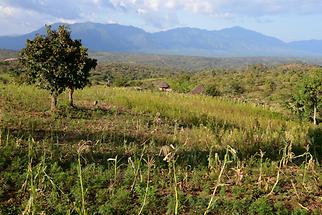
[{"x1": 20, "y1": 26, "x2": 97, "y2": 111}]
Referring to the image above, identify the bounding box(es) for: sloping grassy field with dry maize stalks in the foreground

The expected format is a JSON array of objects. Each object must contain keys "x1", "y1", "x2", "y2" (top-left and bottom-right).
[{"x1": 0, "y1": 84, "x2": 322, "y2": 214}]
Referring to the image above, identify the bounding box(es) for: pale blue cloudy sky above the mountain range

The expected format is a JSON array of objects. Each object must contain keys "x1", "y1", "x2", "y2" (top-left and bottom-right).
[{"x1": 0, "y1": 0, "x2": 322, "y2": 41}]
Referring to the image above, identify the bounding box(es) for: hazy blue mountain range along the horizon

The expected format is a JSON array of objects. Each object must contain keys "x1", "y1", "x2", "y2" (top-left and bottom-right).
[{"x1": 0, "y1": 22, "x2": 322, "y2": 57}]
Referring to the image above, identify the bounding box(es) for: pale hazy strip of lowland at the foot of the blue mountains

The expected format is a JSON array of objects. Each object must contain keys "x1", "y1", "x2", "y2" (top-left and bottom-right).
[{"x1": 90, "y1": 52, "x2": 322, "y2": 71}]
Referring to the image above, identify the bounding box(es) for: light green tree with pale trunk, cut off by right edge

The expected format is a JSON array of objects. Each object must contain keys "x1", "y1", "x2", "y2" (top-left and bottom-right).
[{"x1": 290, "y1": 68, "x2": 322, "y2": 125}]
